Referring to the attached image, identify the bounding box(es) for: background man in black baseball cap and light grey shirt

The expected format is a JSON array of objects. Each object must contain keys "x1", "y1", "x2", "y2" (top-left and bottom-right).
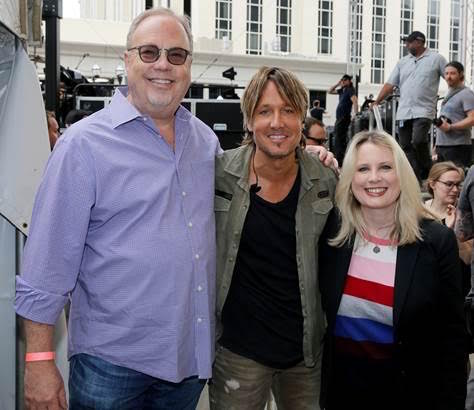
[{"x1": 373, "y1": 31, "x2": 446, "y2": 180}]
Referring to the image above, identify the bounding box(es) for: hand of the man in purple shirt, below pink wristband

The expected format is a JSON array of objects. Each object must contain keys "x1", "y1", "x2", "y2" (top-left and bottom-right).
[{"x1": 25, "y1": 360, "x2": 67, "y2": 410}]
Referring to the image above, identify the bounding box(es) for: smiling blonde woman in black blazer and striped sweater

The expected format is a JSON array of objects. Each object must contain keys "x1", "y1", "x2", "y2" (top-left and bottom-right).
[{"x1": 320, "y1": 131, "x2": 466, "y2": 410}]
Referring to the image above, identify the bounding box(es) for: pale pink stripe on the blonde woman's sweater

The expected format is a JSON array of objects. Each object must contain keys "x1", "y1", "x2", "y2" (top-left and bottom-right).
[{"x1": 348, "y1": 253, "x2": 395, "y2": 287}]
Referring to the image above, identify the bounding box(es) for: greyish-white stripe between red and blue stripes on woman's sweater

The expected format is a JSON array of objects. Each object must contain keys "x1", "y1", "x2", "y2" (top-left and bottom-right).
[{"x1": 337, "y1": 295, "x2": 393, "y2": 326}]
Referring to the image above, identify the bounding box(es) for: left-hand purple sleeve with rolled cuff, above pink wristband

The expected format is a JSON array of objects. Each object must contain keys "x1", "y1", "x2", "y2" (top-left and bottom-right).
[{"x1": 15, "y1": 135, "x2": 95, "y2": 324}]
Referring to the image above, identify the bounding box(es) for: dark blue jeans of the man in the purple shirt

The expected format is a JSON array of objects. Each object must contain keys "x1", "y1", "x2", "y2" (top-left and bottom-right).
[{"x1": 69, "y1": 353, "x2": 206, "y2": 410}]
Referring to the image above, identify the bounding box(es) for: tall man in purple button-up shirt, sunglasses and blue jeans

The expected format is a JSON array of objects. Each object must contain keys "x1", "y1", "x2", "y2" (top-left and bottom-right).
[{"x1": 15, "y1": 9, "x2": 220, "y2": 410}]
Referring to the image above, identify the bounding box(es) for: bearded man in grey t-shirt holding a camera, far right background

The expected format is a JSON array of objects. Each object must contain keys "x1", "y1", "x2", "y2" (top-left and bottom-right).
[{"x1": 435, "y1": 61, "x2": 474, "y2": 167}]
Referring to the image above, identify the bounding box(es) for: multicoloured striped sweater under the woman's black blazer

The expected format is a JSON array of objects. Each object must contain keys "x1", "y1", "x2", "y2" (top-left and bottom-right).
[{"x1": 334, "y1": 236, "x2": 397, "y2": 360}]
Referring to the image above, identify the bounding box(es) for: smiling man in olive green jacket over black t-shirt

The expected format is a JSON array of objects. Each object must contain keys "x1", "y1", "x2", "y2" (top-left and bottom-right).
[{"x1": 210, "y1": 67, "x2": 336, "y2": 410}]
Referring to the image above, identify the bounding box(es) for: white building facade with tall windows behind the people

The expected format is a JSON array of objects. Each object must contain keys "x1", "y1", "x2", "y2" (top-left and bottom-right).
[{"x1": 32, "y1": 0, "x2": 472, "y2": 124}]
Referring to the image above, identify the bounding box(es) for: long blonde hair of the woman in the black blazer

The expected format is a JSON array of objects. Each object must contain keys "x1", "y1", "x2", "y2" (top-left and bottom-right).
[{"x1": 329, "y1": 131, "x2": 434, "y2": 246}]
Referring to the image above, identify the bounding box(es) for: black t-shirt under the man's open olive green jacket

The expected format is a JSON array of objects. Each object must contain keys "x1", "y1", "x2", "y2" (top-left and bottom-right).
[{"x1": 219, "y1": 173, "x2": 303, "y2": 369}]
